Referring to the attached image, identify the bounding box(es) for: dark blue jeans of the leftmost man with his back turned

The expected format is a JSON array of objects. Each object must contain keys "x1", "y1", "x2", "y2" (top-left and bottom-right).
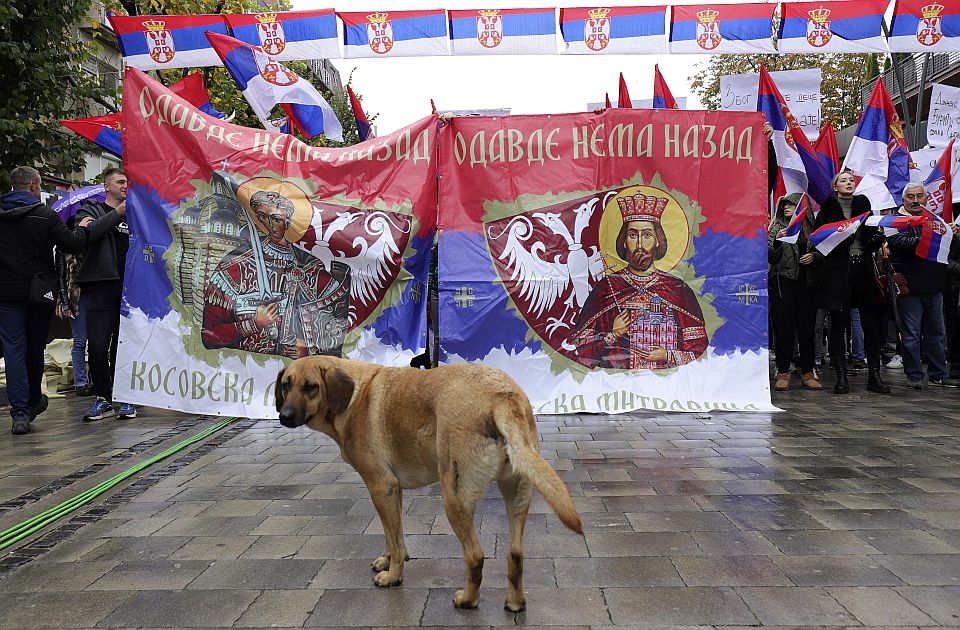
[{"x1": 0, "y1": 302, "x2": 53, "y2": 416}]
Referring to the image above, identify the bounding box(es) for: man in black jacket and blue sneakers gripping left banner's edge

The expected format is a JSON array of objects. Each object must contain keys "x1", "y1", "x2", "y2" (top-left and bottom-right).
[{"x1": 77, "y1": 168, "x2": 137, "y2": 421}]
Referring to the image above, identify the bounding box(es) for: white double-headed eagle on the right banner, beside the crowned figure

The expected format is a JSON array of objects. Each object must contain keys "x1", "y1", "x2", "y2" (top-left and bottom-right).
[{"x1": 488, "y1": 197, "x2": 606, "y2": 336}]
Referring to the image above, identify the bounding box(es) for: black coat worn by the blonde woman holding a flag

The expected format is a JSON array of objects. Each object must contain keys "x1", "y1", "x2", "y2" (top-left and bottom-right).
[{"x1": 810, "y1": 195, "x2": 884, "y2": 311}]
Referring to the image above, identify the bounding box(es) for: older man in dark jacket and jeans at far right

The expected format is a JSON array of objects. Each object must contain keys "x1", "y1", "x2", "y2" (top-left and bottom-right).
[{"x1": 887, "y1": 183, "x2": 960, "y2": 389}]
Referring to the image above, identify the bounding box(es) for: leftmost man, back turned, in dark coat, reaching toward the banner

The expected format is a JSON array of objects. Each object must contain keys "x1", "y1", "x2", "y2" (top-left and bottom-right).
[{"x1": 0, "y1": 166, "x2": 119, "y2": 435}]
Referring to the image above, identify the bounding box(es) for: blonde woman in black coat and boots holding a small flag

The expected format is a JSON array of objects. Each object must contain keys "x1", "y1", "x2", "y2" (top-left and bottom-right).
[{"x1": 811, "y1": 171, "x2": 890, "y2": 394}]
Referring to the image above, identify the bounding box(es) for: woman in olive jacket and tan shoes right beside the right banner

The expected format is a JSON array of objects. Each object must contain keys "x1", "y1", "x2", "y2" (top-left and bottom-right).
[{"x1": 767, "y1": 193, "x2": 821, "y2": 391}]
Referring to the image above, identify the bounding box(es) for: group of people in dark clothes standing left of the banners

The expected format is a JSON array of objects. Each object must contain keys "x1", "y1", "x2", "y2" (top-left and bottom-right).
[{"x1": 0, "y1": 166, "x2": 137, "y2": 435}]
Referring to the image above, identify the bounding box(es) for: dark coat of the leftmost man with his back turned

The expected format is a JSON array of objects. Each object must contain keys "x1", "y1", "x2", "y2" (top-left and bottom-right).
[{"x1": 0, "y1": 190, "x2": 110, "y2": 302}]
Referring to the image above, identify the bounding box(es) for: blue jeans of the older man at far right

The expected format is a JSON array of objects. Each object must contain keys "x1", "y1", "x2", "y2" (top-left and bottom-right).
[{"x1": 897, "y1": 293, "x2": 948, "y2": 381}]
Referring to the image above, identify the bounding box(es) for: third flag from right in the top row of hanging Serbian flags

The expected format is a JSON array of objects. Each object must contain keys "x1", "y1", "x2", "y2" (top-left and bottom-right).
[{"x1": 670, "y1": 3, "x2": 777, "y2": 54}]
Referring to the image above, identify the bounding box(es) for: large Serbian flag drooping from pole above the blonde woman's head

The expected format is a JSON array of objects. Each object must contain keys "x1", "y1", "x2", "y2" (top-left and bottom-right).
[{"x1": 844, "y1": 78, "x2": 910, "y2": 212}]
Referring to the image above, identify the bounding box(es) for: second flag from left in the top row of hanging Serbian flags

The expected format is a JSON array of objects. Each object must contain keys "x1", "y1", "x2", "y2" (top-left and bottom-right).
[{"x1": 224, "y1": 9, "x2": 340, "y2": 61}]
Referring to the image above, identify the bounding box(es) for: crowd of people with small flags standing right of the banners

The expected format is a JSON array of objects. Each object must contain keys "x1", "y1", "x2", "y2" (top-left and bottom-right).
[{"x1": 768, "y1": 172, "x2": 960, "y2": 394}]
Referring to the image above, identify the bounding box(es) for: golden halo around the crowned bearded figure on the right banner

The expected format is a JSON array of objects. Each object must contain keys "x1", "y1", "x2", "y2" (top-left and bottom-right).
[{"x1": 600, "y1": 186, "x2": 690, "y2": 272}]
